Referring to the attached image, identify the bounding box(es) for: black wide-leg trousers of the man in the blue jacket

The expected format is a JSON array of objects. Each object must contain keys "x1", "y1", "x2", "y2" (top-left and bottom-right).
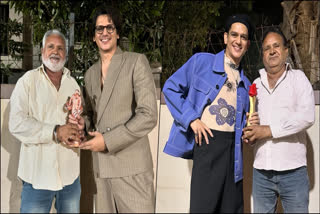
[{"x1": 190, "y1": 130, "x2": 243, "y2": 213}]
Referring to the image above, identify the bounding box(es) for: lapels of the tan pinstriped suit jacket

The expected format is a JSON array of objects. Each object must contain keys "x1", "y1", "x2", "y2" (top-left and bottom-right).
[{"x1": 97, "y1": 47, "x2": 124, "y2": 123}]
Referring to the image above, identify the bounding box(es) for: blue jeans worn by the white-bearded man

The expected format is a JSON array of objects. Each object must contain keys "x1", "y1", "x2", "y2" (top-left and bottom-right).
[{"x1": 20, "y1": 177, "x2": 81, "y2": 213}]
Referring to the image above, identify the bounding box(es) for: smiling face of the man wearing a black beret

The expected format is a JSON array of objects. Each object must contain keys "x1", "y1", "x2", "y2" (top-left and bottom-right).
[{"x1": 224, "y1": 22, "x2": 250, "y2": 65}]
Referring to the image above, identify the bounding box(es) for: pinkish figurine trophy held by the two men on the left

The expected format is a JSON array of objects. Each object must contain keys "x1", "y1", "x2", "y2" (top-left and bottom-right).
[{"x1": 63, "y1": 89, "x2": 83, "y2": 146}]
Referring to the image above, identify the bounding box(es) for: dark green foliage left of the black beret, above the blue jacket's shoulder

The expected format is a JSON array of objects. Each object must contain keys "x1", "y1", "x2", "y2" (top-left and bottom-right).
[{"x1": 161, "y1": 1, "x2": 223, "y2": 85}]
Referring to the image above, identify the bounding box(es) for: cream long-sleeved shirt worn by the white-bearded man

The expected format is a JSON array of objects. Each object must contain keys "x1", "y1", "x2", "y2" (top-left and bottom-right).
[{"x1": 9, "y1": 66, "x2": 80, "y2": 191}]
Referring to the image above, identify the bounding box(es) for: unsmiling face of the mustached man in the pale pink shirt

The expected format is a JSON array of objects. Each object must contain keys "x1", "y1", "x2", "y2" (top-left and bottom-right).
[{"x1": 262, "y1": 32, "x2": 288, "y2": 73}]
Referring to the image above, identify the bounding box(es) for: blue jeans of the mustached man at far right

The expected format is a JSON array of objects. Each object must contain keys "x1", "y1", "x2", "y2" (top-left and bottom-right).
[{"x1": 252, "y1": 166, "x2": 309, "y2": 213}]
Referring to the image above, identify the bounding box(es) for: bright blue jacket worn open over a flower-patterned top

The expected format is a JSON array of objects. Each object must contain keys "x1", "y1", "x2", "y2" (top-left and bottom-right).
[{"x1": 163, "y1": 50, "x2": 251, "y2": 182}]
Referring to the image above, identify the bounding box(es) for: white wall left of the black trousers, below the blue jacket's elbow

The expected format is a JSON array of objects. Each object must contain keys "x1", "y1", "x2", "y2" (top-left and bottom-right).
[{"x1": 156, "y1": 105, "x2": 192, "y2": 213}]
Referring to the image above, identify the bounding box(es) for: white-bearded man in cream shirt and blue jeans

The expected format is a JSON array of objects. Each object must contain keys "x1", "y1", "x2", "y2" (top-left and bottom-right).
[{"x1": 9, "y1": 30, "x2": 83, "y2": 213}]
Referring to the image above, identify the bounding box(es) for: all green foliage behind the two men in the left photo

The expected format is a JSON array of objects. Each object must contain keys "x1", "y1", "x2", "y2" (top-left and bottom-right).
[{"x1": 10, "y1": 0, "x2": 165, "y2": 84}]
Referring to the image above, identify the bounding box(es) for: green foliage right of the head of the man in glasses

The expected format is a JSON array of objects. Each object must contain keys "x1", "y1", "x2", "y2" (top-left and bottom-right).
[{"x1": 118, "y1": 0, "x2": 165, "y2": 63}]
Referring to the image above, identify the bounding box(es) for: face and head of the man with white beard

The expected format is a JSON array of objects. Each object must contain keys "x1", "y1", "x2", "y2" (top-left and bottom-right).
[{"x1": 41, "y1": 34, "x2": 66, "y2": 72}]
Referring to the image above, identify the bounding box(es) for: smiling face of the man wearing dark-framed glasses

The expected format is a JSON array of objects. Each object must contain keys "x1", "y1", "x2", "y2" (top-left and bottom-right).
[{"x1": 93, "y1": 15, "x2": 119, "y2": 53}]
